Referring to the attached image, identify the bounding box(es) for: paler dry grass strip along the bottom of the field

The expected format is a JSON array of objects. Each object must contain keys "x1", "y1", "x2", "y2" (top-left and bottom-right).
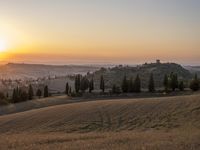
[{"x1": 0, "y1": 130, "x2": 200, "y2": 150}]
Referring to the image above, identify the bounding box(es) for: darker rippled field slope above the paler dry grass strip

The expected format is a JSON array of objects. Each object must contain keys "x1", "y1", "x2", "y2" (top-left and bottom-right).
[{"x1": 0, "y1": 95, "x2": 200, "y2": 133}]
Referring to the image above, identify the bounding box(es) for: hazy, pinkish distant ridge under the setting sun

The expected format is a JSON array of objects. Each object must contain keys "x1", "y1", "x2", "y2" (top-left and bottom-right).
[{"x1": 0, "y1": 63, "x2": 100, "y2": 79}]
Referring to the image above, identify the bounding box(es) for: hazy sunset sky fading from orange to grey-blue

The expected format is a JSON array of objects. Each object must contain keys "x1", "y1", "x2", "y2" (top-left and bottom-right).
[{"x1": 0, "y1": 0, "x2": 200, "y2": 65}]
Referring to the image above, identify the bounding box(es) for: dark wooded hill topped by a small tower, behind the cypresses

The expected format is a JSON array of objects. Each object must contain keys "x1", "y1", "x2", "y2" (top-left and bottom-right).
[{"x1": 89, "y1": 63, "x2": 192, "y2": 88}]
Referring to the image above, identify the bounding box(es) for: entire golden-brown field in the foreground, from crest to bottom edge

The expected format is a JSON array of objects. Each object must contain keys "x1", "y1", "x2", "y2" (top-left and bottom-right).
[{"x1": 0, "y1": 95, "x2": 200, "y2": 150}]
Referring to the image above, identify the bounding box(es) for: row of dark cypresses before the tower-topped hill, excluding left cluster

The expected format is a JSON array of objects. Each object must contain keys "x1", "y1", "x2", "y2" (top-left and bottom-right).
[{"x1": 66, "y1": 72, "x2": 200, "y2": 95}]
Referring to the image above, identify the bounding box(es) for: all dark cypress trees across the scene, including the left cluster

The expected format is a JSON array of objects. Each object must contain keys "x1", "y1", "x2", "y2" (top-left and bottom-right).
[{"x1": 4, "y1": 72, "x2": 200, "y2": 103}]
